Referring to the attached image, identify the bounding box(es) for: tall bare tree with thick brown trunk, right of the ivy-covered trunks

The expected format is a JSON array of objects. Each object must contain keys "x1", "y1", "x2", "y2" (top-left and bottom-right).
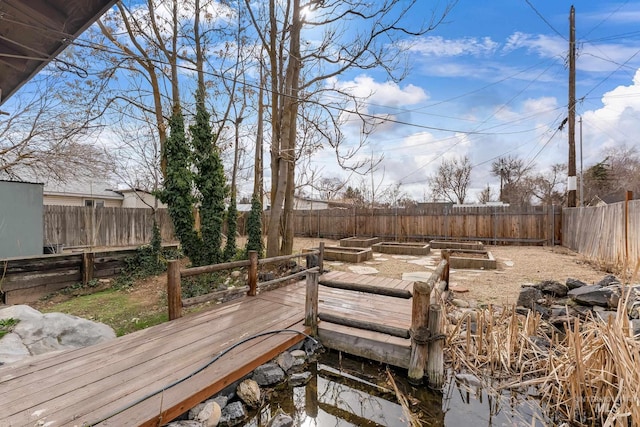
[{"x1": 245, "y1": 0, "x2": 458, "y2": 256}]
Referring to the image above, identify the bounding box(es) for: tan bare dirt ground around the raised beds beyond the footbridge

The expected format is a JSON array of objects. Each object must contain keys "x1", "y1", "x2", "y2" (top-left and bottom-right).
[{"x1": 294, "y1": 238, "x2": 608, "y2": 305}]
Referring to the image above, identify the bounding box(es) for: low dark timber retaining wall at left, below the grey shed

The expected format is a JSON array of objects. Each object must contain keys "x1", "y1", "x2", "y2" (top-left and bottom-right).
[{"x1": 0, "y1": 248, "x2": 170, "y2": 304}]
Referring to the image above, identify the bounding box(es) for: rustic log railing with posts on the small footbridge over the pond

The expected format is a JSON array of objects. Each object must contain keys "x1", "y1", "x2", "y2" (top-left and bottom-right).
[{"x1": 305, "y1": 250, "x2": 449, "y2": 388}]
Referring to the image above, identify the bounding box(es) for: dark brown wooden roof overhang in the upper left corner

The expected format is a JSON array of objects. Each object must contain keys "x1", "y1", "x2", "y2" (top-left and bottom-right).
[{"x1": 0, "y1": 0, "x2": 116, "y2": 105}]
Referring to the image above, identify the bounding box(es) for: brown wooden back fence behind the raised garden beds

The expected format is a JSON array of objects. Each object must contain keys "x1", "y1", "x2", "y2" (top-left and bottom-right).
[{"x1": 276, "y1": 206, "x2": 562, "y2": 244}]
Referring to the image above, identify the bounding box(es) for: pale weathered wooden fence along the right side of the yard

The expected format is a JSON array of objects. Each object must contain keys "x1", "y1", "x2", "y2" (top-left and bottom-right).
[{"x1": 562, "y1": 200, "x2": 640, "y2": 272}]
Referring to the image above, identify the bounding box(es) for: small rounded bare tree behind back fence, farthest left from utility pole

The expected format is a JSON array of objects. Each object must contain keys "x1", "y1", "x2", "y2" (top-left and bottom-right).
[{"x1": 429, "y1": 156, "x2": 473, "y2": 204}]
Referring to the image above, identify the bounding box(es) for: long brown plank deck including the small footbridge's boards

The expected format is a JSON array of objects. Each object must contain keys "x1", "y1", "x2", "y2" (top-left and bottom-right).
[{"x1": 0, "y1": 272, "x2": 413, "y2": 427}]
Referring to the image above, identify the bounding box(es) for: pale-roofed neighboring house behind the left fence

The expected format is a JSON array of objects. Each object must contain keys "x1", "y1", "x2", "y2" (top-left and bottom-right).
[{"x1": 43, "y1": 182, "x2": 167, "y2": 208}]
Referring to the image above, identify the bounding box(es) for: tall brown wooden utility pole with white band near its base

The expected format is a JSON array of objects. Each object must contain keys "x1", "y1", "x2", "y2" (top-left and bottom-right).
[{"x1": 567, "y1": 5, "x2": 577, "y2": 208}]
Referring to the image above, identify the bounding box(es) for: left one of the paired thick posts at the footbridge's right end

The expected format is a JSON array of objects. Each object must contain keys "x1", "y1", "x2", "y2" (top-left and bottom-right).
[{"x1": 409, "y1": 282, "x2": 431, "y2": 384}]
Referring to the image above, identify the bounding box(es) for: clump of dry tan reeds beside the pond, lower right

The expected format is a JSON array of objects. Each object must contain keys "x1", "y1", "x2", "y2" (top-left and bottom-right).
[{"x1": 446, "y1": 292, "x2": 640, "y2": 426}]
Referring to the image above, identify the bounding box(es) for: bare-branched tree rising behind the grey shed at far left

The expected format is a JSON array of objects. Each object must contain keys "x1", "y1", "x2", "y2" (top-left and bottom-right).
[{"x1": 0, "y1": 81, "x2": 113, "y2": 182}]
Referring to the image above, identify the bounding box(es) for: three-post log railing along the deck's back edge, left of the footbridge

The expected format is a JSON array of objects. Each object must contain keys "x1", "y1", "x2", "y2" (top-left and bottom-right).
[{"x1": 167, "y1": 242, "x2": 324, "y2": 320}]
